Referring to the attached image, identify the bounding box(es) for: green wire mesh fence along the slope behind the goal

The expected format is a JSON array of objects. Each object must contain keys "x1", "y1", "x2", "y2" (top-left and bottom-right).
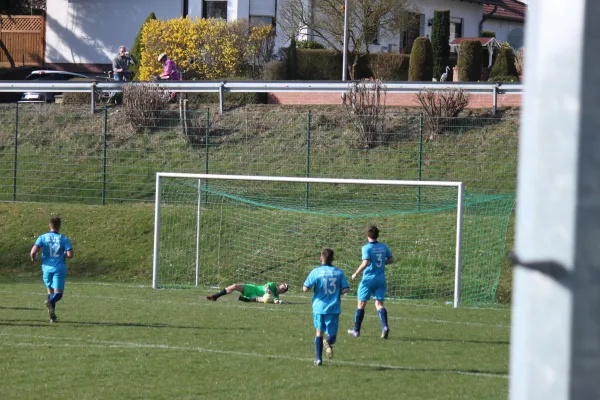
[{"x1": 0, "y1": 104, "x2": 519, "y2": 204}]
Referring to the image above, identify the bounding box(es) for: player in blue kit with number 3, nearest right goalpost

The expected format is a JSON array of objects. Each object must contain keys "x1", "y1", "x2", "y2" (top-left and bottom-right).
[{"x1": 348, "y1": 226, "x2": 394, "y2": 339}]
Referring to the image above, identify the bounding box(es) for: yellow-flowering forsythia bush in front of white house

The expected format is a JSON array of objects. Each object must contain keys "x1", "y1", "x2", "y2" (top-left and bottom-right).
[{"x1": 140, "y1": 17, "x2": 274, "y2": 80}]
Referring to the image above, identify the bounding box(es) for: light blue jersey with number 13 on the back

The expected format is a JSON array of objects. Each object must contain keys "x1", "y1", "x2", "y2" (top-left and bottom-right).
[{"x1": 304, "y1": 265, "x2": 350, "y2": 314}]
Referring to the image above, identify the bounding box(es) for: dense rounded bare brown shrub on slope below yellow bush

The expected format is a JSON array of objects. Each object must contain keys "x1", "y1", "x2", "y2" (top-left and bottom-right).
[{"x1": 123, "y1": 82, "x2": 171, "y2": 130}]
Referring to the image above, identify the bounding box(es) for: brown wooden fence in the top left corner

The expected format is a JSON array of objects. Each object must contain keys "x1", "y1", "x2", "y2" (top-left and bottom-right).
[{"x1": 0, "y1": 15, "x2": 46, "y2": 67}]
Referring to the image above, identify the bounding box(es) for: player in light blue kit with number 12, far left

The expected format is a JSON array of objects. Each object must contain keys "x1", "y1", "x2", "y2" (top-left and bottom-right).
[{"x1": 29, "y1": 216, "x2": 73, "y2": 322}]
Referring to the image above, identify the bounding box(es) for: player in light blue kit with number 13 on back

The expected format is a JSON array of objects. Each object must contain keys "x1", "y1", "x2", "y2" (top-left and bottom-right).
[{"x1": 302, "y1": 249, "x2": 350, "y2": 366}]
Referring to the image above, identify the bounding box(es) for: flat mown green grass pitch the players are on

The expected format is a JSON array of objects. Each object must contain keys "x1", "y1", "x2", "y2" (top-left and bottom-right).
[{"x1": 0, "y1": 277, "x2": 510, "y2": 400}]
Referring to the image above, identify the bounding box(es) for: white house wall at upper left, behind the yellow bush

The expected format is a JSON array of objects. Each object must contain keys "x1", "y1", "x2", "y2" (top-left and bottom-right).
[{"x1": 45, "y1": 0, "x2": 276, "y2": 72}]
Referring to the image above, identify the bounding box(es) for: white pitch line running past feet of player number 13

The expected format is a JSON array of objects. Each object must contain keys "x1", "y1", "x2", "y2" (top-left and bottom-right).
[{"x1": 0, "y1": 333, "x2": 508, "y2": 379}]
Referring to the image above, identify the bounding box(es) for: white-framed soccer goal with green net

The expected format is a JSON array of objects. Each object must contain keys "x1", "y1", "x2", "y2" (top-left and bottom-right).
[{"x1": 152, "y1": 172, "x2": 514, "y2": 307}]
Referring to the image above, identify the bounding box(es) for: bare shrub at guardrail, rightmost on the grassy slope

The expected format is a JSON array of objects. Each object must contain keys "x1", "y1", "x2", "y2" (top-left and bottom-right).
[{"x1": 416, "y1": 89, "x2": 469, "y2": 139}]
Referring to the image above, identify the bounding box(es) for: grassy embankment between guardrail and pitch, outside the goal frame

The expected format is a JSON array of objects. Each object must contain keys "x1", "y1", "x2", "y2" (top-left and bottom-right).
[{"x1": 0, "y1": 107, "x2": 518, "y2": 301}]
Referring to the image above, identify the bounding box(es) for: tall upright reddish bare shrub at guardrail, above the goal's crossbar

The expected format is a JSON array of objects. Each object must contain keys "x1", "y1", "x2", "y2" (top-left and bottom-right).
[{"x1": 344, "y1": 79, "x2": 386, "y2": 148}]
